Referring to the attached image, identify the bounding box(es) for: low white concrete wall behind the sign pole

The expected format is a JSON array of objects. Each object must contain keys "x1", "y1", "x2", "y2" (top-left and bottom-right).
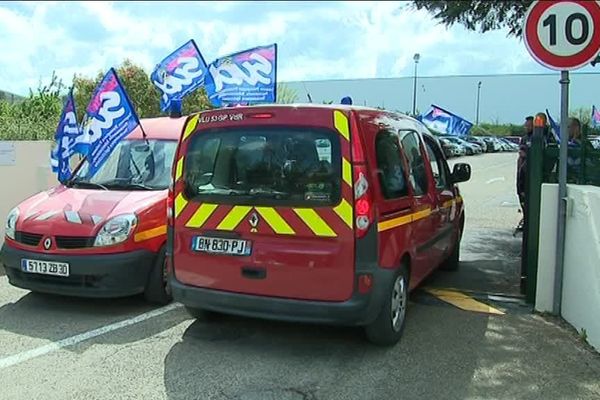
[{"x1": 535, "y1": 185, "x2": 600, "y2": 351}]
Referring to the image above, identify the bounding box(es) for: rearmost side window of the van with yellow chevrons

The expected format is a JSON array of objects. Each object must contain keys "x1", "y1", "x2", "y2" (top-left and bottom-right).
[{"x1": 375, "y1": 131, "x2": 408, "y2": 199}]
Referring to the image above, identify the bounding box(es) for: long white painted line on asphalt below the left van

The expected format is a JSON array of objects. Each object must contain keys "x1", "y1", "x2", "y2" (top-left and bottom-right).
[{"x1": 0, "y1": 303, "x2": 181, "y2": 370}]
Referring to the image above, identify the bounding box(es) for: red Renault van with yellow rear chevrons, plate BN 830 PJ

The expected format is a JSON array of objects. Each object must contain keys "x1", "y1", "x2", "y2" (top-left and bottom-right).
[{"x1": 167, "y1": 104, "x2": 470, "y2": 345}]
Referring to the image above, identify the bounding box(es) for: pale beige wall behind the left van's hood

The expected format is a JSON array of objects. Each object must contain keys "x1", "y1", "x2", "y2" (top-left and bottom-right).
[{"x1": 0, "y1": 141, "x2": 58, "y2": 245}]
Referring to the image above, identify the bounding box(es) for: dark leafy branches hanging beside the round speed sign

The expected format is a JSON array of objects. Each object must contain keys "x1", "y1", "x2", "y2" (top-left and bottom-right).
[{"x1": 413, "y1": 0, "x2": 533, "y2": 37}]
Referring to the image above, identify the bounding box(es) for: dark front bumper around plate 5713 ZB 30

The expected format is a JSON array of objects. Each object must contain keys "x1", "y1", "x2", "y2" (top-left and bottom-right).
[{"x1": 0, "y1": 243, "x2": 156, "y2": 297}]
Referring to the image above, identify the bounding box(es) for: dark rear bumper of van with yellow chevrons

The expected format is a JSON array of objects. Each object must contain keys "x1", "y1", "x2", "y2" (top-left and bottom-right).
[{"x1": 171, "y1": 268, "x2": 395, "y2": 326}]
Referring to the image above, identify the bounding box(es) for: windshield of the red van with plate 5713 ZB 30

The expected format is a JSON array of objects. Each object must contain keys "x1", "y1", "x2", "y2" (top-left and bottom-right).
[{"x1": 70, "y1": 140, "x2": 177, "y2": 190}]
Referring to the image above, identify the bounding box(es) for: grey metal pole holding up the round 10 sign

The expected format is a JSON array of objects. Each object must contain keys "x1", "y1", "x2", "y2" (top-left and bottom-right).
[{"x1": 553, "y1": 71, "x2": 569, "y2": 315}]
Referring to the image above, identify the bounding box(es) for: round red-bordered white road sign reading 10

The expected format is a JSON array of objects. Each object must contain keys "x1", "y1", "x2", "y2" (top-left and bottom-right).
[{"x1": 523, "y1": 0, "x2": 600, "y2": 70}]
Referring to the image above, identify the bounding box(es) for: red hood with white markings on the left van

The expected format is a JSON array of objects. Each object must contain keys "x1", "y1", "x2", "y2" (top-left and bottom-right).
[{"x1": 17, "y1": 186, "x2": 167, "y2": 236}]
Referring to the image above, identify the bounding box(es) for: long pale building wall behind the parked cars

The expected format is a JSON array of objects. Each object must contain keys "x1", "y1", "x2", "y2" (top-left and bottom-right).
[{"x1": 286, "y1": 72, "x2": 600, "y2": 124}]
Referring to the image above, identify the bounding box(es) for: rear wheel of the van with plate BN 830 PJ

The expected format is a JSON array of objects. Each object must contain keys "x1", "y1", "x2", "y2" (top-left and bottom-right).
[{"x1": 365, "y1": 265, "x2": 408, "y2": 346}]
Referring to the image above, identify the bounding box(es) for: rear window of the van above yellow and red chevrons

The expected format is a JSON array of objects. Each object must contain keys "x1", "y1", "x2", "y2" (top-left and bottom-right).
[{"x1": 184, "y1": 127, "x2": 342, "y2": 207}]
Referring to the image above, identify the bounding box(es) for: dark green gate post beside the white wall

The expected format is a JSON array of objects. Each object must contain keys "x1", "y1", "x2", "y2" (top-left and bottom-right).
[{"x1": 521, "y1": 117, "x2": 546, "y2": 304}]
